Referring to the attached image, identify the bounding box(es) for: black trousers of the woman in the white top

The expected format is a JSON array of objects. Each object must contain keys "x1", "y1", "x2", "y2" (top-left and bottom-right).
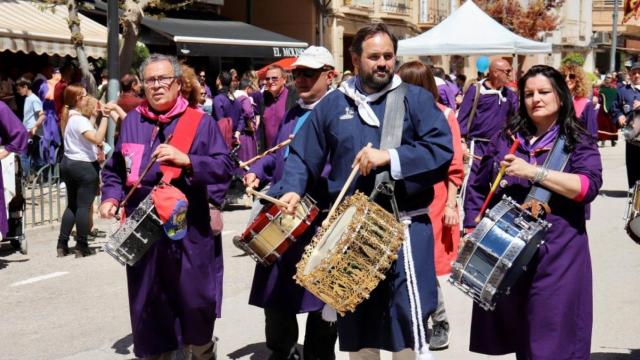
[{"x1": 58, "y1": 157, "x2": 100, "y2": 248}]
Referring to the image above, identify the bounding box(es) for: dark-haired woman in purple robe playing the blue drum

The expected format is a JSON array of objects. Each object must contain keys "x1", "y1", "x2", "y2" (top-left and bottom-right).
[{"x1": 464, "y1": 65, "x2": 602, "y2": 360}]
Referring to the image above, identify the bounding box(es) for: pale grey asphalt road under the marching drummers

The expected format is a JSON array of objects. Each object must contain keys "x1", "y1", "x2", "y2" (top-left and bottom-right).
[{"x1": 0, "y1": 144, "x2": 640, "y2": 360}]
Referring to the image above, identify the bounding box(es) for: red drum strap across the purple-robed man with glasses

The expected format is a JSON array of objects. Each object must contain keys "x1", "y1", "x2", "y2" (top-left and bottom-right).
[{"x1": 160, "y1": 107, "x2": 202, "y2": 184}]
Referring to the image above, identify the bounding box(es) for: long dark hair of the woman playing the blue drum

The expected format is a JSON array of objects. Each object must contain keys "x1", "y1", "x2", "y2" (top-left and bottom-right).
[{"x1": 507, "y1": 65, "x2": 586, "y2": 152}]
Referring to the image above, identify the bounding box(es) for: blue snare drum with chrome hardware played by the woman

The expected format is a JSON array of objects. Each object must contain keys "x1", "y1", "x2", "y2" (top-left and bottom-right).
[{"x1": 449, "y1": 196, "x2": 551, "y2": 310}]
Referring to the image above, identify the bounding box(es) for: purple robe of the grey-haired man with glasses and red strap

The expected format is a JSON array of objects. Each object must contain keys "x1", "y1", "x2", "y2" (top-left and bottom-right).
[{"x1": 102, "y1": 107, "x2": 233, "y2": 357}]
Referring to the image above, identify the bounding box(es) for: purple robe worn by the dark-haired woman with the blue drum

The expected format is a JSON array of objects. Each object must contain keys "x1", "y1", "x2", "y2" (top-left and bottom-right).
[{"x1": 464, "y1": 134, "x2": 602, "y2": 360}]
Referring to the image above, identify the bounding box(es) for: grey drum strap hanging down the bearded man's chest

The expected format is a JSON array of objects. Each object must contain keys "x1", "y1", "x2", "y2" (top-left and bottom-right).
[{"x1": 370, "y1": 83, "x2": 407, "y2": 219}]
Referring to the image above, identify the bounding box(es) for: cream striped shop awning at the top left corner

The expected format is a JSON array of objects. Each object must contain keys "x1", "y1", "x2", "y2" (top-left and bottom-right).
[{"x1": 0, "y1": 0, "x2": 107, "y2": 58}]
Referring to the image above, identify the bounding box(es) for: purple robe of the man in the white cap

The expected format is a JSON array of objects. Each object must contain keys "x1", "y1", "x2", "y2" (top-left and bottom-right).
[{"x1": 249, "y1": 106, "x2": 326, "y2": 314}]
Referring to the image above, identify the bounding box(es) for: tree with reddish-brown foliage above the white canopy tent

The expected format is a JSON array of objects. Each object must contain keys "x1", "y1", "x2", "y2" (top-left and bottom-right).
[{"x1": 476, "y1": 0, "x2": 564, "y2": 40}]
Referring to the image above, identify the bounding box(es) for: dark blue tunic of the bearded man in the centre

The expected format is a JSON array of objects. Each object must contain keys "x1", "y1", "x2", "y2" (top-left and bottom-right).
[{"x1": 271, "y1": 81, "x2": 453, "y2": 351}]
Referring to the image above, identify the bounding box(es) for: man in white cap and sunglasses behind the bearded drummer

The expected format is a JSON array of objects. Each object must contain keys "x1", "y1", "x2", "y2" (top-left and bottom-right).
[{"x1": 244, "y1": 46, "x2": 337, "y2": 360}]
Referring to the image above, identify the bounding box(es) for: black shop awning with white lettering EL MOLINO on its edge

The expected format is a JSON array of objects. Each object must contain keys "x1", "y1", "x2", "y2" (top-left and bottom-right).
[{"x1": 142, "y1": 17, "x2": 308, "y2": 58}]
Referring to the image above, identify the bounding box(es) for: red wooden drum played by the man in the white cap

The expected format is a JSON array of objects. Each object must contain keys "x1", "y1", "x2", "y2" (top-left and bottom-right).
[{"x1": 239, "y1": 196, "x2": 320, "y2": 266}]
